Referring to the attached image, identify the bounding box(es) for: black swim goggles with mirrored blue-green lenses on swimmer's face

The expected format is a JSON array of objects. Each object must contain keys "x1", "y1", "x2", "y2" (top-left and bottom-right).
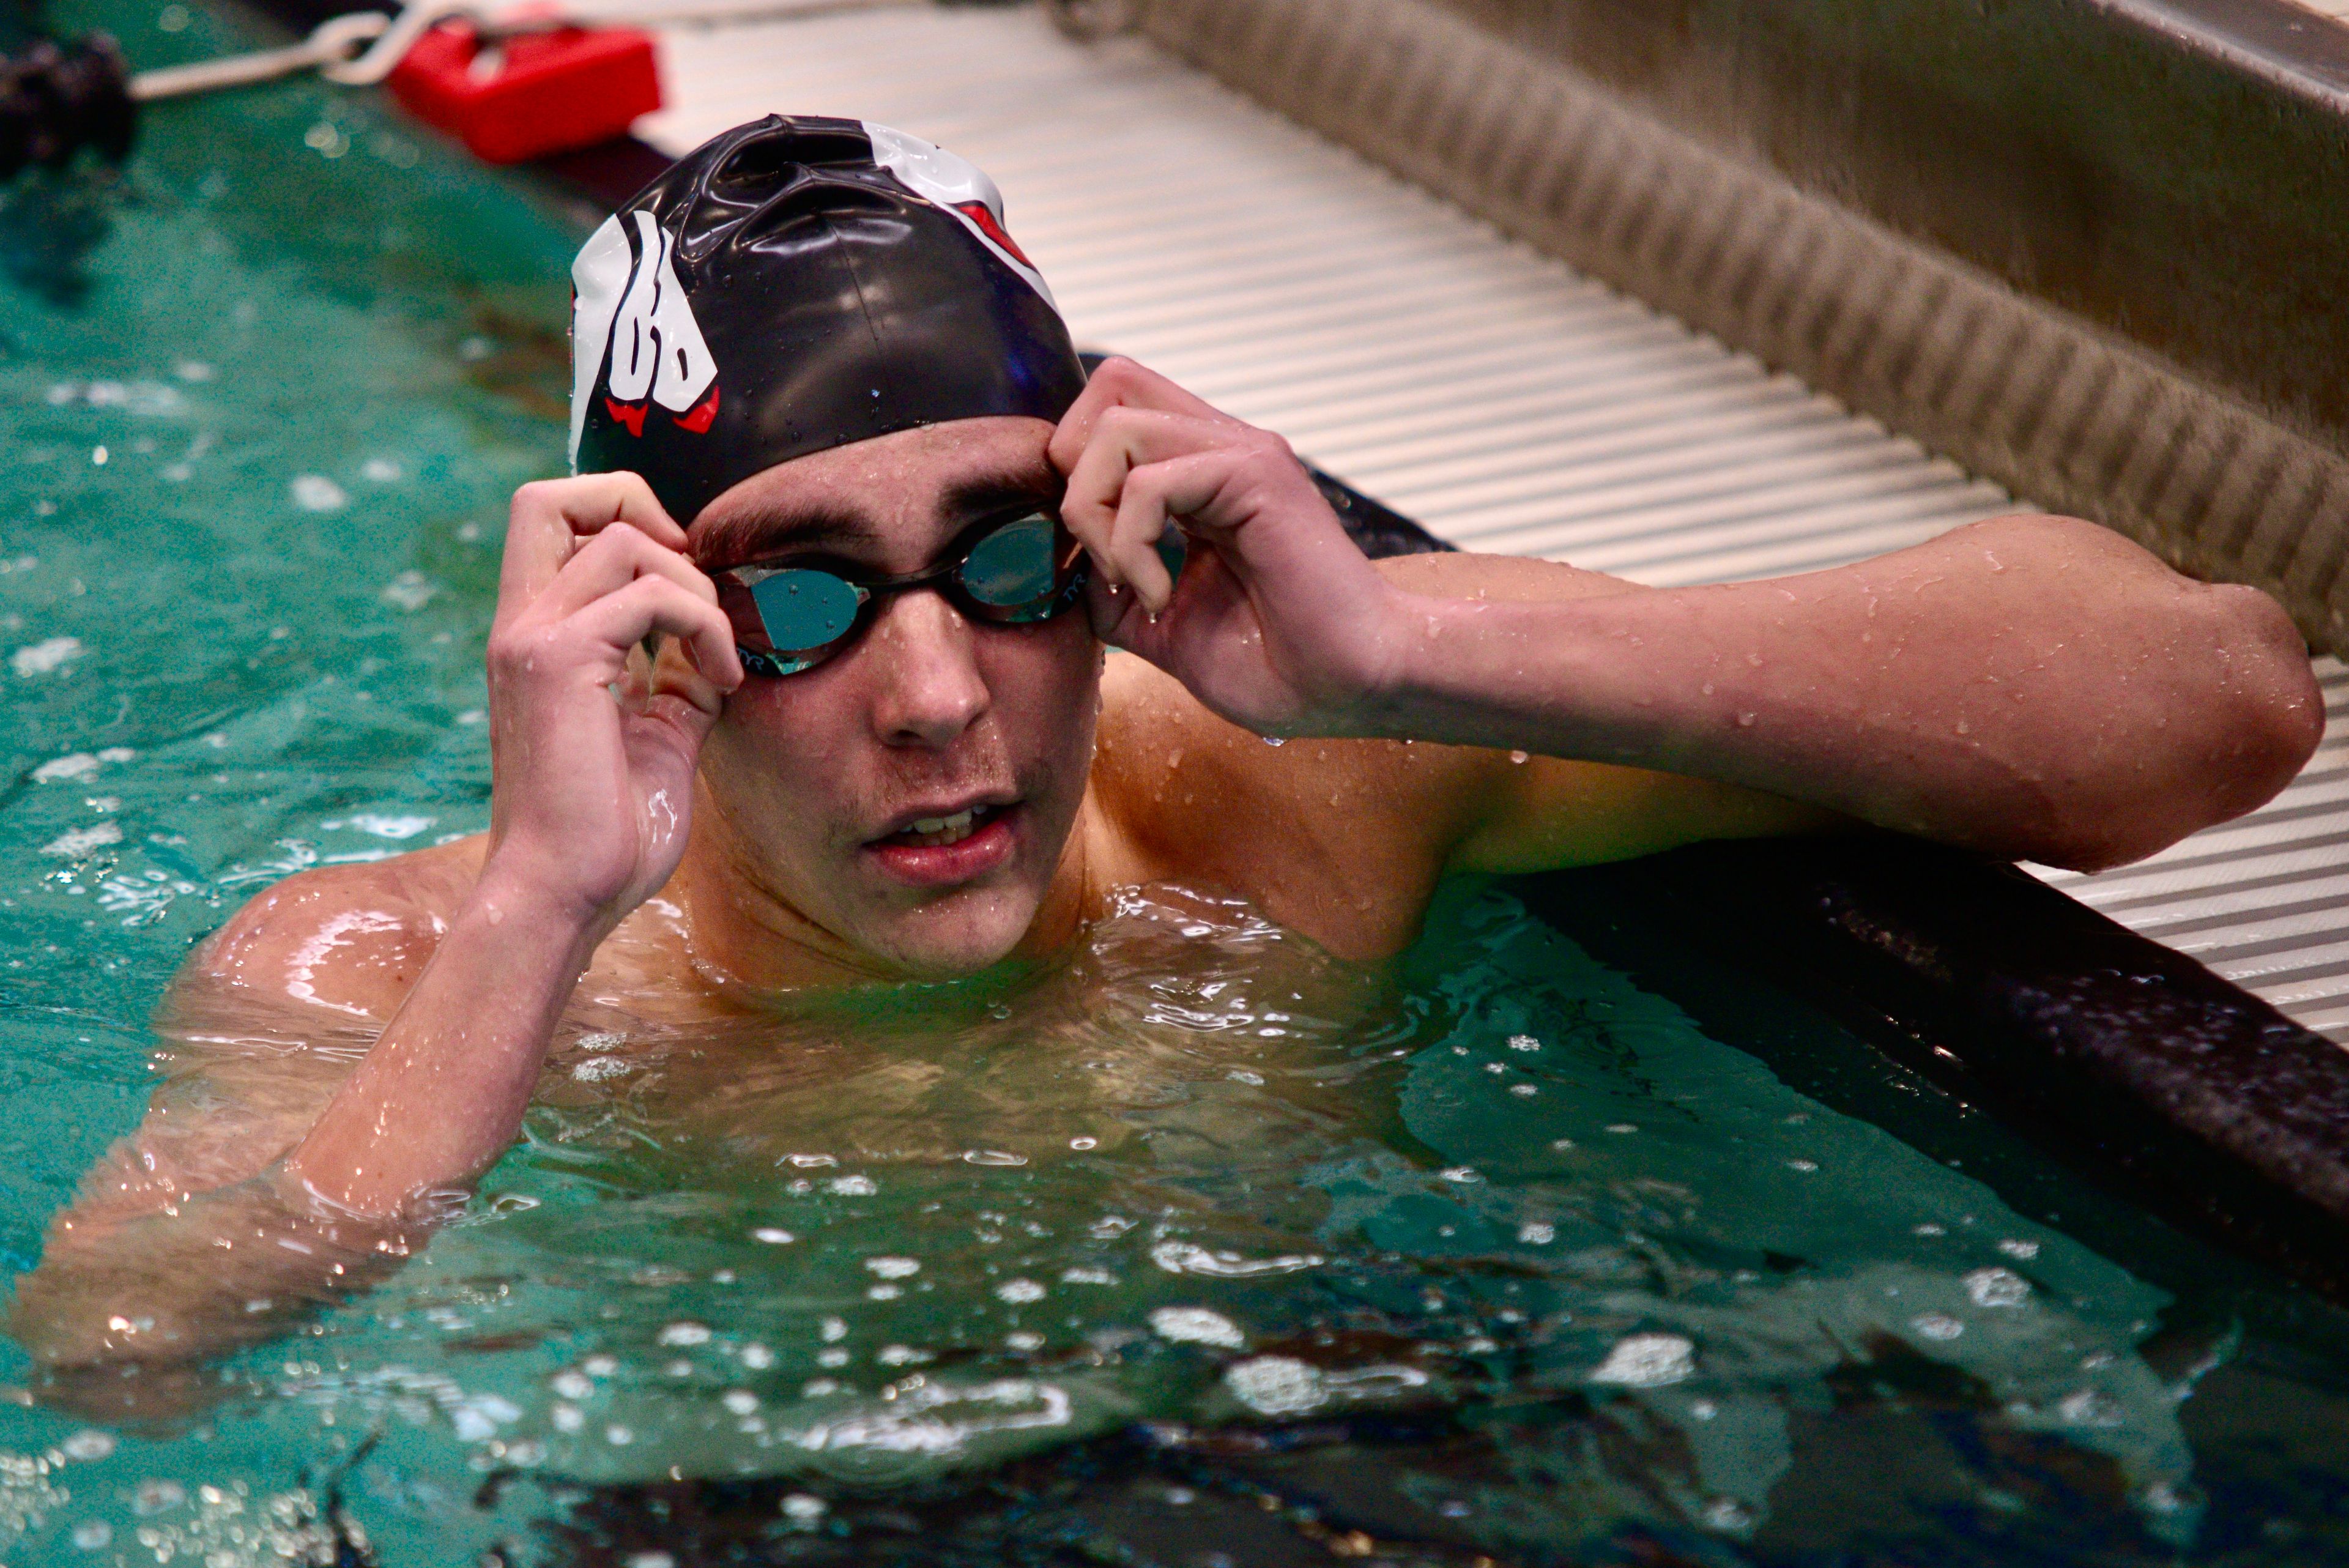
[{"x1": 710, "y1": 508, "x2": 1085, "y2": 675}]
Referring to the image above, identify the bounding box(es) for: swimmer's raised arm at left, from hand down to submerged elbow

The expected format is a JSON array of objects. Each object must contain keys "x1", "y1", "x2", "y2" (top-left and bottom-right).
[{"x1": 14, "y1": 475, "x2": 742, "y2": 1366}]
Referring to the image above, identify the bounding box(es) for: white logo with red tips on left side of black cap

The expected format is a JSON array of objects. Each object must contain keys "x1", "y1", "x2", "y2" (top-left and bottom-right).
[{"x1": 571, "y1": 212, "x2": 719, "y2": 470}]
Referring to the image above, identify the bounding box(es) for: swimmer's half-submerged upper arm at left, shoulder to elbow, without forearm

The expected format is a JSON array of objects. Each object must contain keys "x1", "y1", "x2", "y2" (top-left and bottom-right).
[{"x1": 7, "y1": 851, "x2": 448, "y2": 1401}]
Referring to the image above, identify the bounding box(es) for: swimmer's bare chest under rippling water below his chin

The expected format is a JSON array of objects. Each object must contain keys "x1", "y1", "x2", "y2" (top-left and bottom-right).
[{"x1": 536, "y1": 886, "x2": 1390, "y2": 1178}]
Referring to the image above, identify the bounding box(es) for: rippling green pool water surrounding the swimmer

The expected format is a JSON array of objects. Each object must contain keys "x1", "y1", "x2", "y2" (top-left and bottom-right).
[{"x1": 0, "y1": 5, "x2": 2349, "y2": 1568}]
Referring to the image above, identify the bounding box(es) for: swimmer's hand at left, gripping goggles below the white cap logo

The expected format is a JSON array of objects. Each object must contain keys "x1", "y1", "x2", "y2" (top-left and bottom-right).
[{"x1": 484, "y1": 472, "x2": 742, "y2": 938}]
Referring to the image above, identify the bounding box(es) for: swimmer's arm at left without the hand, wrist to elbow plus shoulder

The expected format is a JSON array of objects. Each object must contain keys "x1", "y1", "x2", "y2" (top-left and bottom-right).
[{"x1": 7, "y1": 874, "x2": 595, "y2": 1403}]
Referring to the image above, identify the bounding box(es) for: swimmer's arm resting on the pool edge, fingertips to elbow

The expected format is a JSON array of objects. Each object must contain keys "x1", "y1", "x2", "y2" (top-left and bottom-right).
[{"x1": 1052, "y1": 360, "x2": 2323, "y2": 868}]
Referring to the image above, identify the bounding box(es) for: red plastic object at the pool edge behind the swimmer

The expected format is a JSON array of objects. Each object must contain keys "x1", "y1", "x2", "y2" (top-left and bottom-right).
[{"x1": 388, "y1": 23, "x2": 660, "y2": 162}]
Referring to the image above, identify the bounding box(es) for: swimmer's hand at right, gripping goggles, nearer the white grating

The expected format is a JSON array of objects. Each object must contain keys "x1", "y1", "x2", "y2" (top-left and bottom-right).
[{"x1": 1050, "y1": 360, "x2": 1402, "y2": 736}]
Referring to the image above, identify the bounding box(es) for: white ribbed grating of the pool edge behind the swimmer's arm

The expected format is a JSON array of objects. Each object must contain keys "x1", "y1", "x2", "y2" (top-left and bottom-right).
[{"x1": 634, "y1": 0, "x2": 2349, "y2": 1039}]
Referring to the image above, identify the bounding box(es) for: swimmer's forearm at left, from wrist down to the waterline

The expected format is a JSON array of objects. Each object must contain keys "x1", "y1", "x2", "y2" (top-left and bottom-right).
[{"x1": 286, "y1": 879, "x2": 601, "y2": 1217}]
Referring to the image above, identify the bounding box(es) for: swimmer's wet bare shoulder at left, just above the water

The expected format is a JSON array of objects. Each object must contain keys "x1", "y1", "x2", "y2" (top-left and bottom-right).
[{"x1": 179, "y1": 834, "x2": 489, "y2": 1020}]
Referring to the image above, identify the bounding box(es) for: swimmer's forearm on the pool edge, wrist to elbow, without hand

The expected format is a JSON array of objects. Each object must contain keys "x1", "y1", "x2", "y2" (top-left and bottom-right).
[{"x1": 1365, "y1": 517, "x2": 2321, "y2": 865}]
